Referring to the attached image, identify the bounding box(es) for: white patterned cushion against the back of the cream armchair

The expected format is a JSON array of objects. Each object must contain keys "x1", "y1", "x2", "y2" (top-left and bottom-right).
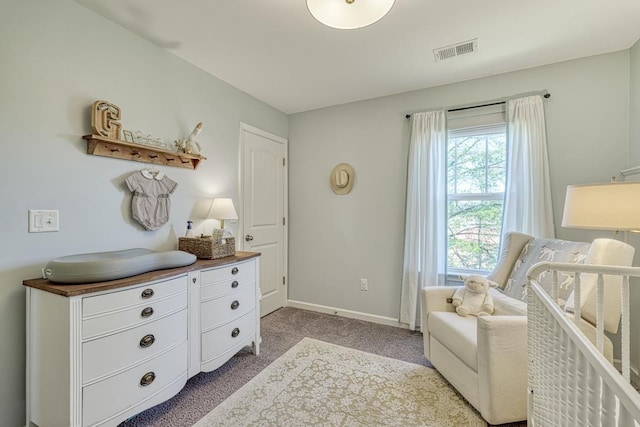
[{"x1": 504, "y1": 238, "x2": 590, "y2": 306}]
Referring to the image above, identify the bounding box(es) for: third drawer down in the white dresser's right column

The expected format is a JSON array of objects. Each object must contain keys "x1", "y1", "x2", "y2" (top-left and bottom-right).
[{"x1": 200, "y1": 287, "x2": 256, "y2": 332}]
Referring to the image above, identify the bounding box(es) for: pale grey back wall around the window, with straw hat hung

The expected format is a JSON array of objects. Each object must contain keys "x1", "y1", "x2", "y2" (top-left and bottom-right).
[{"x1": 289, "y1": 50, "x2": 629, "y2": 318}]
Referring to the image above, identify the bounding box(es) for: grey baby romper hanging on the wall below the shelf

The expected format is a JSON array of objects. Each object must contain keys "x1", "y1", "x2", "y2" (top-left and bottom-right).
[{"x1": 125, "y1": 169, "x2": 178, "y2": 230}]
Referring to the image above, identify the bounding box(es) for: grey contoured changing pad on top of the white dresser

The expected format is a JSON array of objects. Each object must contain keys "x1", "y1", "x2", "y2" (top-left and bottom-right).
[{"x1": 43, "y1": 248, "x2": 197, "y2": 283}]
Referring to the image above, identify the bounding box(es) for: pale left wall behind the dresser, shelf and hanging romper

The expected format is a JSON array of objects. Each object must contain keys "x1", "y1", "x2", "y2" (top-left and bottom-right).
[{"x1": 0, "y1": 0, "x2": 288, "y2": 426}]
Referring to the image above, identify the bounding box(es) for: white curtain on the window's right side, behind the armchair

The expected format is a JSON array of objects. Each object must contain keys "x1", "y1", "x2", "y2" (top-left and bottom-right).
[{"x1": 502, "y1": 96, "x2": 555, "y2": 237}]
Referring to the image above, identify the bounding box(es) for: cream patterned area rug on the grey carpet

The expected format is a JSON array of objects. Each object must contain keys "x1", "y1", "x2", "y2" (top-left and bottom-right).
[{"x1": 195, "y1": 338, "x2": 487, "y2": 427}]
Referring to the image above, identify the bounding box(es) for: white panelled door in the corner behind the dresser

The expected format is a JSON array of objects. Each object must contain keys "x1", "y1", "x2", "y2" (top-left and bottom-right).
[{"x1": 240, "y1": 123, "x2": 287, "y2": 316}]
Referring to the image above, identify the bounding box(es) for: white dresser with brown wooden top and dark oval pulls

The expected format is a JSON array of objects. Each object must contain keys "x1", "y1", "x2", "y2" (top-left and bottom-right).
[{"x1": 24, "y1": 252, "x2": 260, "y2": 427}]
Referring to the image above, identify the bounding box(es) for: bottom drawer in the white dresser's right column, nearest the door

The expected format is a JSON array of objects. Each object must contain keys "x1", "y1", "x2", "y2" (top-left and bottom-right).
[{"x1": 202, "y1": 311, "x2": 256, "y2": 363}]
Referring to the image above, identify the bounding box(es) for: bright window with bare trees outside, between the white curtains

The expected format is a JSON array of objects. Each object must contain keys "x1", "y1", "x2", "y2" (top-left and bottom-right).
[{"x1": 447, "y1": 107, "x2": 507, "y2": 275}]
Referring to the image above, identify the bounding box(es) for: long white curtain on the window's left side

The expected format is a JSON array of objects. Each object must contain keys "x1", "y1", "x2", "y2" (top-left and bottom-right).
[{"x1": 400, "y1": 111, "x2": 447, "y2": 330}]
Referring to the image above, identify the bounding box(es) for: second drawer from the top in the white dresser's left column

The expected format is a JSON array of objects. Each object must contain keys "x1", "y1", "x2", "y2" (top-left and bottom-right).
[{"x1": 82, "y1": 290, "x2": 187, "y2": 341}]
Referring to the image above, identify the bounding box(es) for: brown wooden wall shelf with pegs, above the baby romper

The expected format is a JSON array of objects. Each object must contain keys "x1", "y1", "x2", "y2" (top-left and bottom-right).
[{"x1": 82, "y1": 135, "x2": 206, "y2": 169}]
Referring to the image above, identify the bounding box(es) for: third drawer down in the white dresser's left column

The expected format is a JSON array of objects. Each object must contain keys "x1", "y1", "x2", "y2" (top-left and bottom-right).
[{"x1": 82, "y1": 309, "x2": 187, "y2": 384}]
